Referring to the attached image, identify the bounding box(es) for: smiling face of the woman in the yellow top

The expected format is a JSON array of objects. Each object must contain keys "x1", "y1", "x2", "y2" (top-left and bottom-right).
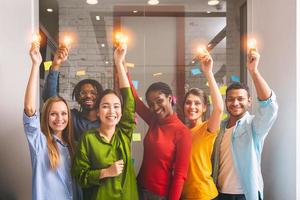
[{"x1": 183, "y1": 94, "x2": 206, "y2": 124}]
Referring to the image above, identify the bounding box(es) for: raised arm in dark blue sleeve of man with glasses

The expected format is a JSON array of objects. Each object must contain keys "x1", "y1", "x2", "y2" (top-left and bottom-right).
[{"x1": 43, "y1": 46, "x2": 69, "y2": 101}]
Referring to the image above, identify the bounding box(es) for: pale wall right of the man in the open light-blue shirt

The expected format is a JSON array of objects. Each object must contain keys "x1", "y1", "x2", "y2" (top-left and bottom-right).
[{"x1": 248, "y1": 0, "x2": 300, "y2": 200}]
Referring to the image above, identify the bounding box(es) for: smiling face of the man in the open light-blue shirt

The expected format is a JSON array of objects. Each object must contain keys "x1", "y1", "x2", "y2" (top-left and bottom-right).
[{"x1": 225, "y1": 89, "x2": 251, "y2": 119}]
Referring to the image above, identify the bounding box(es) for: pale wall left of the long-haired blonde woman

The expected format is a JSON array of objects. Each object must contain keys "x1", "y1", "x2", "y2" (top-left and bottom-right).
[{"x1": 0, "y1": 0, "x2": 38, "y2": 200}]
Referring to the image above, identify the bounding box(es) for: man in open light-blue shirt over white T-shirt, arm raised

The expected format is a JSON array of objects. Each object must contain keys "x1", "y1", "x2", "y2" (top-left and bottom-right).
[{"x1": 212, "y1": 49, "x2": 278, "y2": 200}]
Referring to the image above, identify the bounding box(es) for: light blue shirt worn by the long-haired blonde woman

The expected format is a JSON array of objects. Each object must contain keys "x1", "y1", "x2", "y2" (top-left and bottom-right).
[{"x1": 23, "y1": 113, "x2": 80, "y2": 200}]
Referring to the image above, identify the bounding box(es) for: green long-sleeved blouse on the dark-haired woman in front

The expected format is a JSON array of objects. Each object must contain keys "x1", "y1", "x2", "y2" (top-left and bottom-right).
[{"x1": 72, "y1": 88, "x2": 138, "y2": 200}]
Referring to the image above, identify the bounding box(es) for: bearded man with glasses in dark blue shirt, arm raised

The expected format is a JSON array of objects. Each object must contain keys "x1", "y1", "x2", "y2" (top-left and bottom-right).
[{"x1": 43, "y1": 46, "x2": 103, "y2": 141}]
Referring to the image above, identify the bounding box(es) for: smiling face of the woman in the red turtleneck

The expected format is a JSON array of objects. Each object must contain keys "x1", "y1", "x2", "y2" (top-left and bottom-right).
[{"x1": 146, "y1": 90, "x2": 173, "y2": 119}]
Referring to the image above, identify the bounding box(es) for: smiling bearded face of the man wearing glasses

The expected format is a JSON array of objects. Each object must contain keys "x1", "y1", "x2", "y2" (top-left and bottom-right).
[{"x1": 78, "y1": 83, "x2": 97, "y2": 111}]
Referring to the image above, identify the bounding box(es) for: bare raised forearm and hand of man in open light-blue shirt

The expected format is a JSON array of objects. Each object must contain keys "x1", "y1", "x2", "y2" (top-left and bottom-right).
[{"x1": 247, "y1": 49, "x2": 271, "y2": 101}]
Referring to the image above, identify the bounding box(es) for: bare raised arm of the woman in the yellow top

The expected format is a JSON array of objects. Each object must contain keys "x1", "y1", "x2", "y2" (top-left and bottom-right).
[{"x1": 199, "y1": 50, "x2": 224, "y2": 133}]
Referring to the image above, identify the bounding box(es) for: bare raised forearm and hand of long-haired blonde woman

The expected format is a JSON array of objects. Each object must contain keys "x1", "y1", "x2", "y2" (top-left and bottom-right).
[{"x1": 24, "y1": 42, "x2": 42, "y2": 116}]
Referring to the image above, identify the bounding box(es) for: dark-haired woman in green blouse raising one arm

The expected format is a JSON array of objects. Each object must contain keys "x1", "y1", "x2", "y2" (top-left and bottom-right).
[{"x1": 72, "y1": 45, "x2": 138, "y2": 200}]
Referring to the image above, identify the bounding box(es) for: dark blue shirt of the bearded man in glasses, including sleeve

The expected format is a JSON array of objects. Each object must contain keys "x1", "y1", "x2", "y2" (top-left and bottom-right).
[{"x1": 43, "y1": 69, "x2": 100, "y2": 142}]
